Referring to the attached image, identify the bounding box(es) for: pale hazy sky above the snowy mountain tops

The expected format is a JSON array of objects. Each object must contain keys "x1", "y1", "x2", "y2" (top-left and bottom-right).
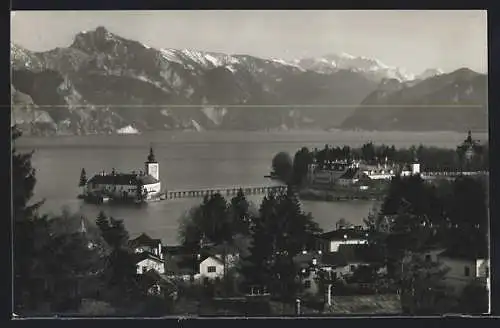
[{"x1": 11, "y1": 10, "x2": 487, "y2": 73}]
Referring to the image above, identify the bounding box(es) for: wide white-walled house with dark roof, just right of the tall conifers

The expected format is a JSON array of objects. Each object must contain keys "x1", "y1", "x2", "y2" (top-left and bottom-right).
[{"x1": 319, "y1": 228, "x2": 368, "y2": 253}]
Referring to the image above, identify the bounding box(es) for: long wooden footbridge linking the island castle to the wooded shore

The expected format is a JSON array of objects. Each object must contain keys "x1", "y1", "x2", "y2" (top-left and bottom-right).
[{"x1": 163, "y1": 185, "x2": 287, "y2": 199}]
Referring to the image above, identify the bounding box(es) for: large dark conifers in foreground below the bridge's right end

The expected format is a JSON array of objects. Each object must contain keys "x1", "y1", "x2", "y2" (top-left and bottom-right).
[{"x1": 242, "y1": 186, "x2": 320, "y2": 298}]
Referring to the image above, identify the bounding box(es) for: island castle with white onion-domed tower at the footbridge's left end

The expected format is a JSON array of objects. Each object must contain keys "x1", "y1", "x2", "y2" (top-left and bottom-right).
[{"x1": 84, "y1": 148, "x2": 161, "y2": 201}]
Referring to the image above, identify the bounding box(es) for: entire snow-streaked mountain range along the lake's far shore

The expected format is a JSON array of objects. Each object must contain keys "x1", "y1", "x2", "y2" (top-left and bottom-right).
[{"x1": 11, "y1": 27, "x2": 487, "y2": 135}]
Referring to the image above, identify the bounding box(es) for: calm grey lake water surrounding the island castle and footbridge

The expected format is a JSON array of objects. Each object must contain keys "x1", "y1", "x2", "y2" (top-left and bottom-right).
[{"x1": 17, "y1": 131, "x2": 487, "y2": 244}]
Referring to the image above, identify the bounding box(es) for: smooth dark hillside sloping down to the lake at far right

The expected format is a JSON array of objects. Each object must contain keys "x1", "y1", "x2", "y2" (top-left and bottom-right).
[{"x1": 341, "y1": 68, "x2": 488, "y2": 132}]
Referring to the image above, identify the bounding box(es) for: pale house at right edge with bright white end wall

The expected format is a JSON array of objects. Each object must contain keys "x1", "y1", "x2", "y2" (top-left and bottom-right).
[{"x1": 438, "y1": 247, "x2": 490, "y2": 294}]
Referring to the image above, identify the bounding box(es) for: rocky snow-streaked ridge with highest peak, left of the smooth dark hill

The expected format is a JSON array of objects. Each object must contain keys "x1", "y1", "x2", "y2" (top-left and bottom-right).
[{"x1": 11, "y1": 27, "x2": 488, "y2": 135}]
